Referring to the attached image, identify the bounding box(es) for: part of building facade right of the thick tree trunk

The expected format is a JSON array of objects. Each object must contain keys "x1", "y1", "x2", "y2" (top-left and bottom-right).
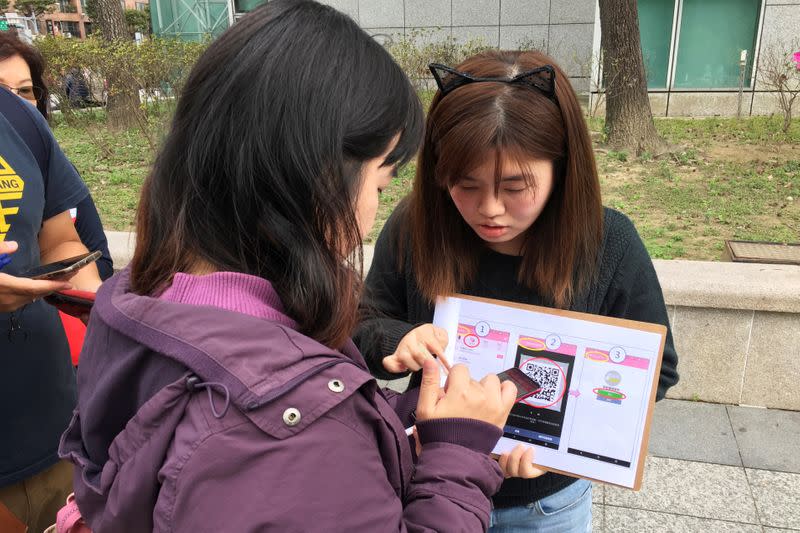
[{"x1": 624, "y1": 0, "x2": 800, "y2": 116}]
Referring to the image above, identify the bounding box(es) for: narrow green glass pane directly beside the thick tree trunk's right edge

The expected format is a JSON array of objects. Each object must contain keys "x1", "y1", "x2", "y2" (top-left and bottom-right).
[{"x1": 638, "y1": 0, "x2": 675, "y2": 89}]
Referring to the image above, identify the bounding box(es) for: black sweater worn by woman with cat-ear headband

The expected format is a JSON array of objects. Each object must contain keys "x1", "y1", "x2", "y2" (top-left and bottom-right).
[{"x1": 354, "y1": 204, "x2": 678, "y2": 508}]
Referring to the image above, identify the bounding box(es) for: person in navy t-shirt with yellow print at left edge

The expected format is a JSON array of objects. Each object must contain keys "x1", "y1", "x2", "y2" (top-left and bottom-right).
[{"x1": 0, "y1": 88, "x2": 101, "y2": 531}]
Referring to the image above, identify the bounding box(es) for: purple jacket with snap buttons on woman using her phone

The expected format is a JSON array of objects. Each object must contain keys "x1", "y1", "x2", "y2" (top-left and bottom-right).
[{"x1": 60, "y1": 270, "x2": 502, "y2": 533}]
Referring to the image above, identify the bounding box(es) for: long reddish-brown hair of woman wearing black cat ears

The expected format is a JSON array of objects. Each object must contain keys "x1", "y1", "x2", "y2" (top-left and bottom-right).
[{"x1": 400, "y1": 50, "x2": 603, "y2": 308}]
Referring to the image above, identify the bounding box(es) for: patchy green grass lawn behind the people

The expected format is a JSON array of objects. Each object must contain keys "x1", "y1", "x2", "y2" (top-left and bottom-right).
[{"x1": 55, "y1": 117, "x2": 800, "y2": 260}]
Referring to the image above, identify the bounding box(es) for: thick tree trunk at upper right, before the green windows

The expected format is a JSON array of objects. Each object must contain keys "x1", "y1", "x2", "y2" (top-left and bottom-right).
[{"x1": 599, "y1": 0, "x2": 665, "y2": 154}]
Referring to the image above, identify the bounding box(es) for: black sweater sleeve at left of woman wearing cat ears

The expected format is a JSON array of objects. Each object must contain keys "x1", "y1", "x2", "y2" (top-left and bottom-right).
[{"x1": 353, "y1": 210, "x2": 415, "y2": 379}]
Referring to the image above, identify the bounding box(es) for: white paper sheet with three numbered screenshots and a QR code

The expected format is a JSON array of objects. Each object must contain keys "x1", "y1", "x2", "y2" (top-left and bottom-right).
[{"x1": 433, "y1": 297, "x2": 664, "y2": 488}]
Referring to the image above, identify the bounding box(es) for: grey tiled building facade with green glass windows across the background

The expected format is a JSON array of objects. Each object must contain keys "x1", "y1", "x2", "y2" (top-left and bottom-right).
[{"x1": 147, "y1": 0, "x2": 800, "y2": 116}]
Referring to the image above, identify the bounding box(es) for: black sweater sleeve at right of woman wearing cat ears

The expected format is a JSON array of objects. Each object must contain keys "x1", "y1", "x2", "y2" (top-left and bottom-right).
[{"x1": 601, "y1": 218, "x2": 678, "y2": 401}]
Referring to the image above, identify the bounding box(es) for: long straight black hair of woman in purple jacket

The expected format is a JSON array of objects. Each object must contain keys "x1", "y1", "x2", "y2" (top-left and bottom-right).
[{"x1": 131, "y1": 0, "x2": 423, "y2": 347}]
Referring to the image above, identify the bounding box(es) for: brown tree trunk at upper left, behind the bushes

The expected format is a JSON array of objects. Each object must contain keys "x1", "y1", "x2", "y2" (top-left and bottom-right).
[{"x1": 95, "y1": 0, "x2": 139, "y2": 129}]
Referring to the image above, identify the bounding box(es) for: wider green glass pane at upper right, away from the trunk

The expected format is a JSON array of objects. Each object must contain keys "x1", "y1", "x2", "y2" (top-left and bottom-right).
[{"x1": 674, "y1": 0, "x2": 761, "y2": 89}]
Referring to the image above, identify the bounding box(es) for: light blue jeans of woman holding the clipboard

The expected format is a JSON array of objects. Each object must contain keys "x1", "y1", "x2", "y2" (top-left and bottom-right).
[{"x1": 489, "y1": 479, "x2": 592, "y2": 533}]
